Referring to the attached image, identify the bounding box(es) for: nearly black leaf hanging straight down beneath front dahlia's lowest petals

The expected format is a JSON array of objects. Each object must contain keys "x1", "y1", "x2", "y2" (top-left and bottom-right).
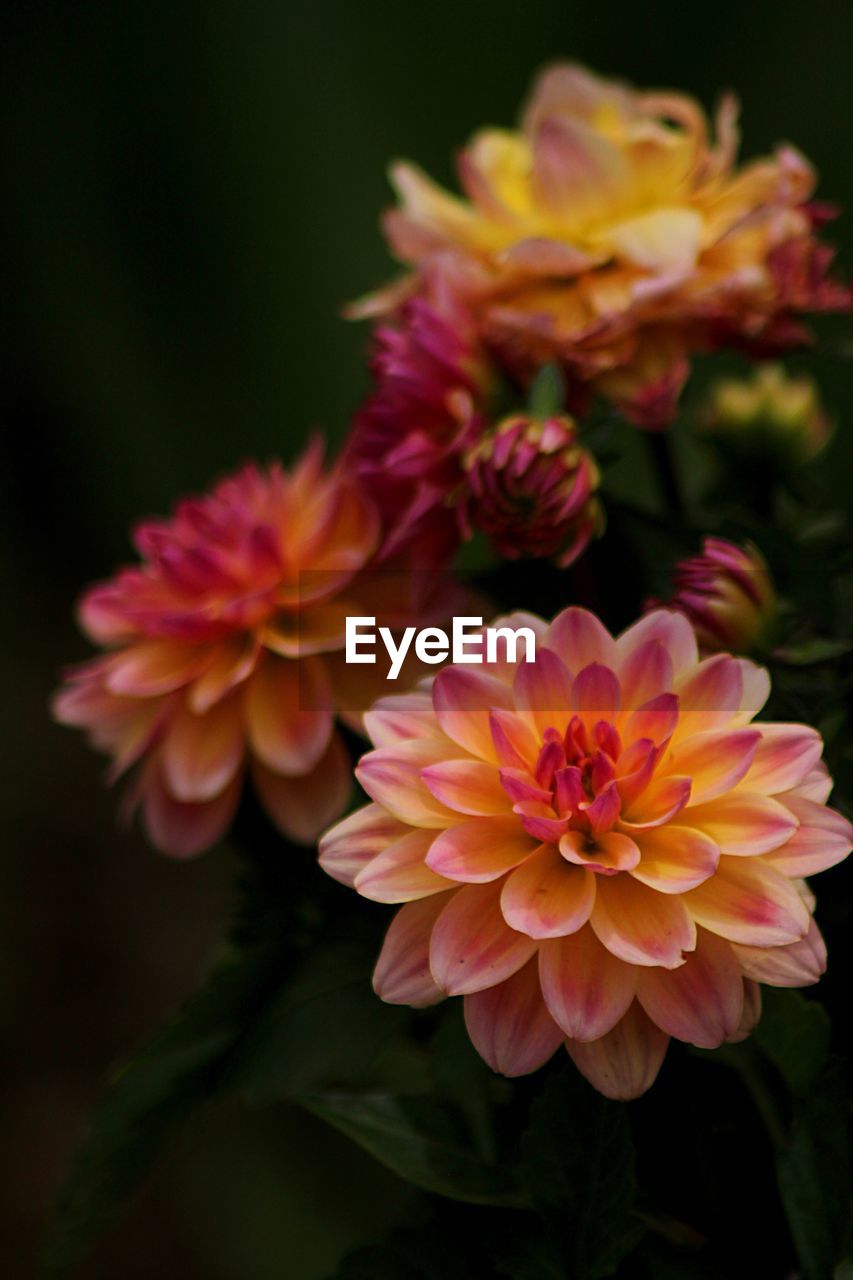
[{"x1": 524, "y1": 1071, "x2": 644, "y2": 1280}]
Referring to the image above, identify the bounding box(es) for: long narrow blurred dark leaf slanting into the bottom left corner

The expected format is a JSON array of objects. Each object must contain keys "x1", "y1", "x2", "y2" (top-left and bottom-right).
[{"x1": 41, "y1": 952, "x2": 279, "y2": 1277}]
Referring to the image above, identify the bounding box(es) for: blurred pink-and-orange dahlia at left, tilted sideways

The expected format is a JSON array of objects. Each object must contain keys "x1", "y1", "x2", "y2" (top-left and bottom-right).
[{"x1": 54, "y1": 443, "x2": 379, "y2": 858}]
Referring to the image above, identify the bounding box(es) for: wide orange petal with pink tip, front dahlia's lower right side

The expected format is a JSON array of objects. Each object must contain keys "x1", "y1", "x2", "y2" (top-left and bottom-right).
[{"x1": 683, "y1": 858, "x2": 809, "y2": 947}]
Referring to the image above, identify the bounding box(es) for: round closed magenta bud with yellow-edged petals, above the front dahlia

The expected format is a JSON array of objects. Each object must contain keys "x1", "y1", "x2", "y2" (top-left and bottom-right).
[{"x1": 462, "y1": 413, "x2": 603, "y2": 567}]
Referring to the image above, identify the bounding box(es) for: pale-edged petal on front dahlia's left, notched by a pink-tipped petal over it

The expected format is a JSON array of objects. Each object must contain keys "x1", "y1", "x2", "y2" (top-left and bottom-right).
[{"x1": 355, "y1": 739, "x2": 457, "y2": 827}]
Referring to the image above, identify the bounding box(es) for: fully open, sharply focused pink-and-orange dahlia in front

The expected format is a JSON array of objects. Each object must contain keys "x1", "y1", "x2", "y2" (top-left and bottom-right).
[{"x1": 320, "y1": 608, "x2": 850, "y2": 1098}]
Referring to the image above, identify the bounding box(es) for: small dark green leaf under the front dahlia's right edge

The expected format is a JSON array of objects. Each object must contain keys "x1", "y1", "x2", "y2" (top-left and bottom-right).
[{"x1": 754, "y1": 987, "x2": 831, "y2": 1094}]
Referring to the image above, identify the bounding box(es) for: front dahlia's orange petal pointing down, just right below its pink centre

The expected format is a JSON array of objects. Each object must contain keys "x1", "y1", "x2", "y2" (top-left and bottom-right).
[{"x1": 590, "y1": 876, "x2": 695, "y2": 969}]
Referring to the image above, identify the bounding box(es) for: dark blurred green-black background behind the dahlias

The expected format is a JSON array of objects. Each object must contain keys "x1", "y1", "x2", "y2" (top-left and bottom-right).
[{"x1": 0, "y1": 0, "x2": 853, "y2": 1280}]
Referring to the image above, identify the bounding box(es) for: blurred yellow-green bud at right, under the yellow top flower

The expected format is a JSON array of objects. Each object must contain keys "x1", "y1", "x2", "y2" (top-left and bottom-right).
[{"x1": 706, "y1": 365, "x2": 833, "y2": 466}]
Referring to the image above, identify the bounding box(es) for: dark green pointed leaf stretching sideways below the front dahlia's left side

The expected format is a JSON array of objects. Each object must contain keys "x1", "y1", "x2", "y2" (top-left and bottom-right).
[{"x1": 295, "y1": 1092, "x2": 519, "y2": 1206}]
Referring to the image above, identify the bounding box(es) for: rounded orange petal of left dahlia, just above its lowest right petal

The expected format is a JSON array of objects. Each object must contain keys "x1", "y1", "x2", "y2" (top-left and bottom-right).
[{"x1": 246, "y1": 653, "x2": 333, "y2": 777}]
